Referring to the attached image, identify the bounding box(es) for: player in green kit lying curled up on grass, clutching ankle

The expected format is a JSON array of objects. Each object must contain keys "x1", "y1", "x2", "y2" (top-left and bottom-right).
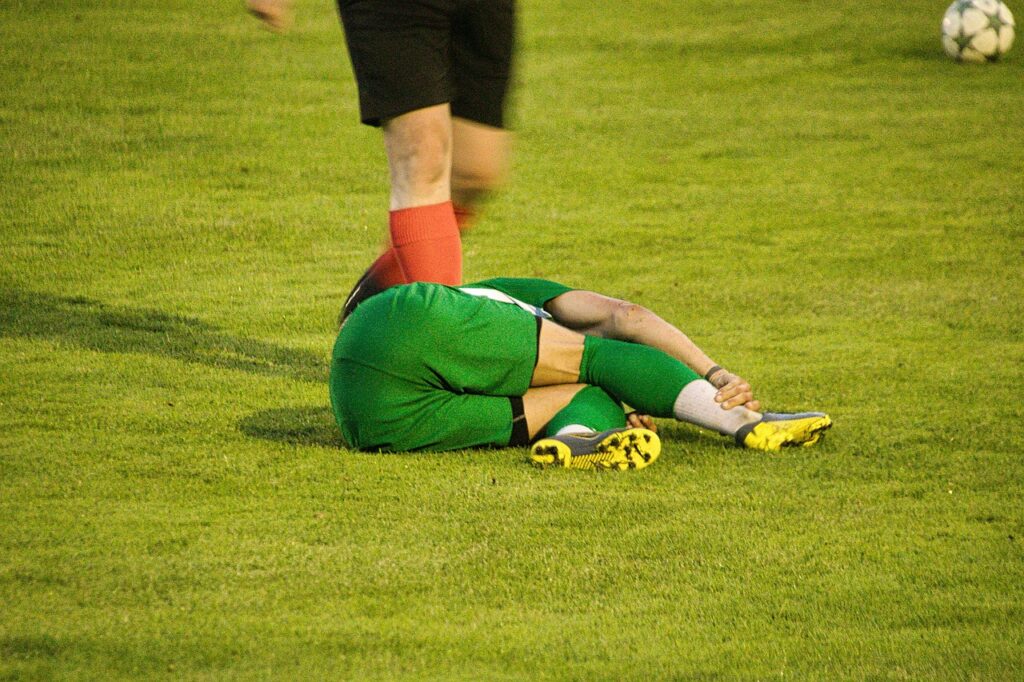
[{"x1": 331, "y1": 279, "x2": 831, "y2": 469}]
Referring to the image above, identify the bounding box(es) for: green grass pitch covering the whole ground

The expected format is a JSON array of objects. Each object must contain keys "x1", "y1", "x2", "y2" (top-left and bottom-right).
[{"x1": 0, "y1": 0, "x2": 1024, "y2": 680}]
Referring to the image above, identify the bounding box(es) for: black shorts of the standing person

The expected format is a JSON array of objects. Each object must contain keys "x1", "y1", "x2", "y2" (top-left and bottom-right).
[{"x1": 338, "y1": 0, "x2": 515, "y2": 128}]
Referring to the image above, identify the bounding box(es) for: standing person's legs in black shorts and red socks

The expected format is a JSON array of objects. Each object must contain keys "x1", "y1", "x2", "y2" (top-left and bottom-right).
[{"x1": 338, "y1": 0, "x2": 515, "y2": 318}]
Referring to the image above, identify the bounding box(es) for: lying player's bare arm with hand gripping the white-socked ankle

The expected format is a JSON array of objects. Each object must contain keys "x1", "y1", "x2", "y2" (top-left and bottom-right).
[{"x1": 545, "y1": 291, "x2": 761, "y2": 411}]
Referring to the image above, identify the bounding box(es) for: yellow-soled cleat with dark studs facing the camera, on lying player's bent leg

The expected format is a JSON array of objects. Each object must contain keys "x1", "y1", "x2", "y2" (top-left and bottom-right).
[{"x1": 529, "y1": 427, "x2": 662, "y2": 471}]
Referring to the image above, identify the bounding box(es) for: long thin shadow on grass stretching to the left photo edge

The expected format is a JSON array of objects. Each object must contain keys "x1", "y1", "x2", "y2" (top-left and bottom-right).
[{"x1": 0, "y1": 288, "x2": 328, "y2": 385}]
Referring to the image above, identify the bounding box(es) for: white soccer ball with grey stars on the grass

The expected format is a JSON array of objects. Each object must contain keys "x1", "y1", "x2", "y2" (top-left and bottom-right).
[{"x1": 942, "y1": 0, "x2": 1014, "y2": 61}]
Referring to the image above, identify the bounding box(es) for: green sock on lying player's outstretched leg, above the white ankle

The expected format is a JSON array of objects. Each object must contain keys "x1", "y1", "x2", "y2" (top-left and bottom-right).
[{"x1": 580, "y1": 336, "x2": 700, "y2": 417}]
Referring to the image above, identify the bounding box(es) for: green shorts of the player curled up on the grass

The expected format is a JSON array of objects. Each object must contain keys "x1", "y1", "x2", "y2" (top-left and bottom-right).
[{"x1": 331, "y1": 283, "x2": 552, "y2": 452}]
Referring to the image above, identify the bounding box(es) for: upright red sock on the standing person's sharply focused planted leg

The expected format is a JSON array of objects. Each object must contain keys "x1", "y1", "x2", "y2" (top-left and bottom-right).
[{"x1": 390, "y1": 202, "x2": 462, "y2": 286}]
